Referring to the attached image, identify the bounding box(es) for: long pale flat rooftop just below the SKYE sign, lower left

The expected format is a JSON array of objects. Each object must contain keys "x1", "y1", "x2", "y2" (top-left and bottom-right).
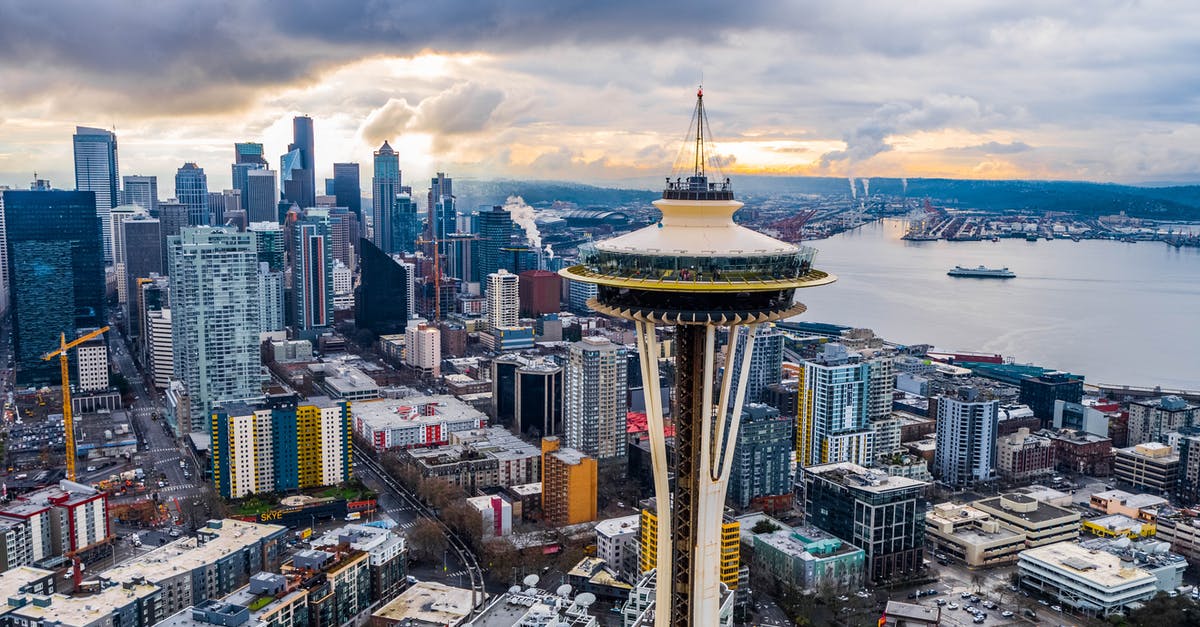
[{"x1": 101, "y1": 518, "x2": 287, "y2": 581}]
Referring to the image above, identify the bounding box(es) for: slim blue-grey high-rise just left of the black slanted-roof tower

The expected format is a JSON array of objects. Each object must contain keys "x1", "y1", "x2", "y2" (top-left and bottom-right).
[{"x1": 292, "y1": 211, "x2": 334, "y2": 333}]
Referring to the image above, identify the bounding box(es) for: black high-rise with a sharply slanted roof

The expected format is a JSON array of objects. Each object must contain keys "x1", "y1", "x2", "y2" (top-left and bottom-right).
[{"x1": 354, "y1": 239, "x2": 414, "y2": 335}]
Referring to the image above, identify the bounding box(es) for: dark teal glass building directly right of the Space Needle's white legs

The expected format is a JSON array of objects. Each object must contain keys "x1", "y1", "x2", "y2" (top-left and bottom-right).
[{"x1": 726, "y1": 402, "x2": 794, "y2": 509}]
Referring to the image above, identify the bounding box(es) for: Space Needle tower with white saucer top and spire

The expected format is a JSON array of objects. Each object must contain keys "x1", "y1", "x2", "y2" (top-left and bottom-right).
[{"x1": 560, "y1": 89, "x2": 836, "y2": 627}]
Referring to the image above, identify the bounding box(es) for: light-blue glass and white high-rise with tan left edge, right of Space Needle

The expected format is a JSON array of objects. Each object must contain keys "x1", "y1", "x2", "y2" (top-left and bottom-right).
[{"x1": 796, "y1": 344, "x2": 874, "y2": 466}]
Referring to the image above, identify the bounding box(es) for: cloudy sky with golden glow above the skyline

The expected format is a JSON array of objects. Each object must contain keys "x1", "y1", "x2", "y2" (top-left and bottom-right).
[{"x1": 0, "y1": 0, "x2": 1200, "y2": 197}]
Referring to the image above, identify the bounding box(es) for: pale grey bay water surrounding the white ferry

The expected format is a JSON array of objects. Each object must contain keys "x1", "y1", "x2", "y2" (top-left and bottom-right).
[{"x1": 799, "y1": 220, "x2": 1200, "y2": 389}]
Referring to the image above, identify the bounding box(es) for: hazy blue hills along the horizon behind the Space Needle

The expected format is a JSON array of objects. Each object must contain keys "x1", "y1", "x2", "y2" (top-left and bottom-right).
[{"x1": 455, "y1": 175, "x2": 1200, "y2": 221}]
